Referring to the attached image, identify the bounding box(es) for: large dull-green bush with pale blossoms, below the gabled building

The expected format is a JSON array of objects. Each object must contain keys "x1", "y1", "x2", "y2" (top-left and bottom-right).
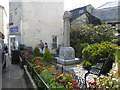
[{"x1": 70, "y1": 24, "x2": 115, "y2": 47}]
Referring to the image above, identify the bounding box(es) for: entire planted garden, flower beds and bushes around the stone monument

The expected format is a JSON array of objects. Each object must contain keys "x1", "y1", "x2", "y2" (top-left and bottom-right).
[{"x1": 20, "y1": 24, "x2": 120, "y2": 90}]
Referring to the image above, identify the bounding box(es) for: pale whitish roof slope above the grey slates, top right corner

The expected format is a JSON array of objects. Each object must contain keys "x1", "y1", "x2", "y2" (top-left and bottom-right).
[{"x1": 97, "y1": 0, "x2": 120, "y2": 9}]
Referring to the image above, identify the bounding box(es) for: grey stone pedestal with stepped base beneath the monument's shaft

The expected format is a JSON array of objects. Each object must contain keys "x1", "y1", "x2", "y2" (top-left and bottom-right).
[{"x1": 56, "y1": 47, "x2": 80, "y2": 65}]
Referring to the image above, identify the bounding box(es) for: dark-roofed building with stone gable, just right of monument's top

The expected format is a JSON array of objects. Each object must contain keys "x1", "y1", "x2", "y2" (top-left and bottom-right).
[{"x1": 70, "y1": 4, "x2": 101, "y2": 28}]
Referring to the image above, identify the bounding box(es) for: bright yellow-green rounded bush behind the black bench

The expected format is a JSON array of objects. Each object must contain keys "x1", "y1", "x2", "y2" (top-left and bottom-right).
[{"x1": 82, "y1": 41, "x2": 117, "y2": 67}]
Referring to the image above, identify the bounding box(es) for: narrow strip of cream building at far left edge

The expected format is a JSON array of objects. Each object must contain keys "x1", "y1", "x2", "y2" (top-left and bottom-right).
[{"x1": 0, "y1": 5, "x2": 8, "y2": 43}]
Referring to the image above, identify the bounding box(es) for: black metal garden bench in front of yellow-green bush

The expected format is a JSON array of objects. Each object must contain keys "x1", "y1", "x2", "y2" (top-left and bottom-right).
[{"x1": 84, "y1": 52, "x2": 113, "y2": 85}]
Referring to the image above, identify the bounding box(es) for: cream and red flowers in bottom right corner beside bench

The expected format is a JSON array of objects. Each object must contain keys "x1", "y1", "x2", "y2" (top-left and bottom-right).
[{"x1": 87, "y1": 64, "x2": 120, "y2": 90}]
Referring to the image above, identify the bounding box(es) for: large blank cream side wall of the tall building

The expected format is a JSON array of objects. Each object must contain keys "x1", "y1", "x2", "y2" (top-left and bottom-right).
[{"x1": 22, "y1": 2, "x2": 64, "y2": 50}]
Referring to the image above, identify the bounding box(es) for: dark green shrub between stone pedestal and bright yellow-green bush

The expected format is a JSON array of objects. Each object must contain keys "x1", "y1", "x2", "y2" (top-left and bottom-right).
[{"x1": 74, "y1": 43, "x2": 89, "y2": 58}]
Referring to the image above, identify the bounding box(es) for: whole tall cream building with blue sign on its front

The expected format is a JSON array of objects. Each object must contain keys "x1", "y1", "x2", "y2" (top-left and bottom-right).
[{"x1": 9, "y1": 0, "x2": 64, "y2": 52}]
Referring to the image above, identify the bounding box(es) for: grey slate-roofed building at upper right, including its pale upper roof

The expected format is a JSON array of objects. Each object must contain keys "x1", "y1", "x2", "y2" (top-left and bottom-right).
[{"x1": 92, "y1": 0, "x2": 120, "y2": 29}]
